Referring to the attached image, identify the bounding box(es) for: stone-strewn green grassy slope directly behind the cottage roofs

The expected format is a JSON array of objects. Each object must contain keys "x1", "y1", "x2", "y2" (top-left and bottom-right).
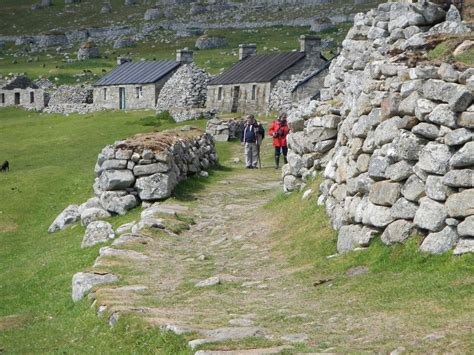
[{"x1": 0, "y1": 25, "x2": 349, "y2": 84}]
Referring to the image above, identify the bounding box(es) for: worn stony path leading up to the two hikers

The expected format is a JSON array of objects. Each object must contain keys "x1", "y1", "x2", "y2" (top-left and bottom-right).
[{"x1": 89, "y1": 143, "x2": 328, "y2": 352}]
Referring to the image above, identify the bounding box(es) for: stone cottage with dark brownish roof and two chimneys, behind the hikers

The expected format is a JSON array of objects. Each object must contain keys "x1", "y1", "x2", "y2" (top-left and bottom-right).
[{"x1": 206, "y1": 36, "x2": 327, "y2": 113}]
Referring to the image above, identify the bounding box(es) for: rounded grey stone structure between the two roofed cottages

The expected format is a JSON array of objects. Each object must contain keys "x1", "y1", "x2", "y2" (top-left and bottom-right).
[{"x1": 156, "y1": 63, "x2": 210, "y2": 122}]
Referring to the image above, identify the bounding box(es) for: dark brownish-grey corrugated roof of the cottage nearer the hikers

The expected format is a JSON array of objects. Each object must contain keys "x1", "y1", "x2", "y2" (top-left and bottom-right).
[{"x1": 209, "y1": 52, "x2": 305, "y2": 85}]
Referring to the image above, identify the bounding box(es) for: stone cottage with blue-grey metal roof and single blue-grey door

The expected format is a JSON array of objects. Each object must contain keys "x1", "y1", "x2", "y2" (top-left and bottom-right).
[{"x1": 93, "y1": 49, "x2": 193, "y2": 110}]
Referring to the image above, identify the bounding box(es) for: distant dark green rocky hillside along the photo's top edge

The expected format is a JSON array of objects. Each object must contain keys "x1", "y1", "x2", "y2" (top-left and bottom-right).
[{"x1": 0, "y1": 0, "x2": 382, "y2": 36}]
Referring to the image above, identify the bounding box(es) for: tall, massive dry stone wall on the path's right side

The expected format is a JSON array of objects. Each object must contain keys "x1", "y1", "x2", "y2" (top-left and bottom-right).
[{"x1": 282, "y1": 3, "x2": 474, "y2": 254}]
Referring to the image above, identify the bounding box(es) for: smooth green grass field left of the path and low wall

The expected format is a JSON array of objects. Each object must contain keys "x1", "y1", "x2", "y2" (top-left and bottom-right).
[{"x1": 0, "y1": 109, "x2": 207, "y2": 353}]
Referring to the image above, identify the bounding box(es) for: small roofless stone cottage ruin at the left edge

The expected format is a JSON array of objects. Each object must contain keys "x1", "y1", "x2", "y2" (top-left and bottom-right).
[{"x1": 0, "y1": 75, "x2": 49, "y2": 111}]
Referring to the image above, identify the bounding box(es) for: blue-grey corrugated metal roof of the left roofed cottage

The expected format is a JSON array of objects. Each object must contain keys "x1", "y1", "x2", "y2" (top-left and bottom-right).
[{"x1": 94, "y1": 60, "x2": 181, "y2": 86}]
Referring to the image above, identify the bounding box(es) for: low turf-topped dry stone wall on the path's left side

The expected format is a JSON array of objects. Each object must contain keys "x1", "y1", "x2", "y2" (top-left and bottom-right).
[{"x1": 48, "y1": 126, "x2": 217, "y2": 234}]
